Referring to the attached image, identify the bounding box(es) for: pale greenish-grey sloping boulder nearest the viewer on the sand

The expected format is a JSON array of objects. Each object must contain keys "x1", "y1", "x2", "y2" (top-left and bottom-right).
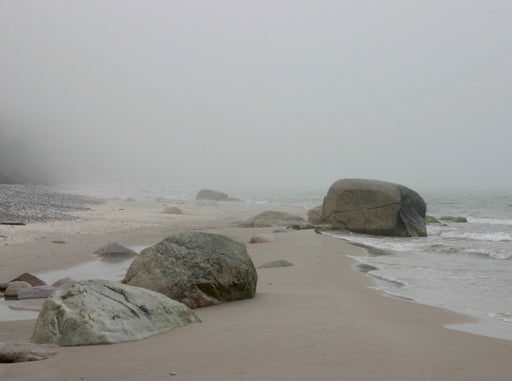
[{"x1": 32, "y1": 280, "x2": 199, "y2": 346}]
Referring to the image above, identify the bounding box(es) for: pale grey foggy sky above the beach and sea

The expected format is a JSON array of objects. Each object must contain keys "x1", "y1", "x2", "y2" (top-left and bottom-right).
[{"x1": 0, "y1": 0, "x2": 512, "y2": 191}]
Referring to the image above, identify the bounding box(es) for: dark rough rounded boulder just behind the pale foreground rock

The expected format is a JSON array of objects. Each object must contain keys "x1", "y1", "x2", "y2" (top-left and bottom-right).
[{"x1": 123, "y1": 232, "x2": 258, "y2": 308}]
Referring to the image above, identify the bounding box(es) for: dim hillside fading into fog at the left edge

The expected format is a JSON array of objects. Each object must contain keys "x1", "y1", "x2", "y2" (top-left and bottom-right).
[{"x1": 0, "y1": 131, "x2": 57, "y2": 185}]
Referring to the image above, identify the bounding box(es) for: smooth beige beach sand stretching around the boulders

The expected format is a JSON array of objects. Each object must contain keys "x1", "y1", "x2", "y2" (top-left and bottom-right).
[{"x1": 0, "y1": 200, "x2": 512, "y2": 381}]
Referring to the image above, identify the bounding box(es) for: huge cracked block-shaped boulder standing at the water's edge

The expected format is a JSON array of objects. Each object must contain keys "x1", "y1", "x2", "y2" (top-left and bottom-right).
[{"x1": 321, "y1": 179, "x2": 427, "y2": 237}]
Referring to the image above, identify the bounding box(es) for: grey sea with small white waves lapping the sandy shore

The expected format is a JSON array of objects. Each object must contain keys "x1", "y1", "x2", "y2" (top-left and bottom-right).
[{"x1": 0, "y1": 186, "x2": 512, "y2": 340}]
